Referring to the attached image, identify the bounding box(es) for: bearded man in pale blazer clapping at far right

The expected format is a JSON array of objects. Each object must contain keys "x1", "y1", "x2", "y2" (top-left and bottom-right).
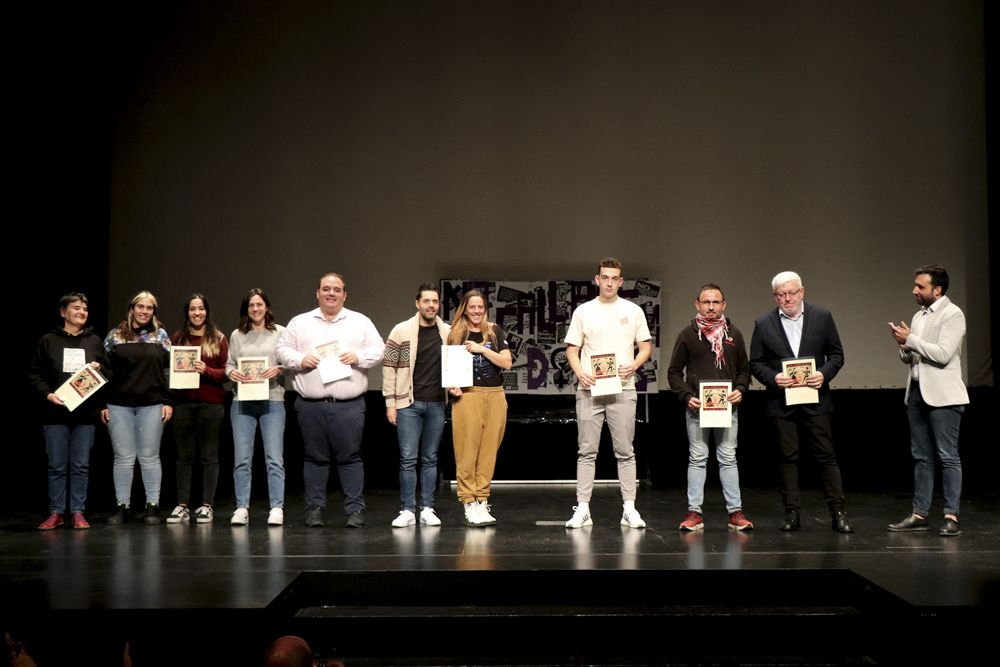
[{"x1": 889, "y1": 264, "x2": 969, "y2": 537}]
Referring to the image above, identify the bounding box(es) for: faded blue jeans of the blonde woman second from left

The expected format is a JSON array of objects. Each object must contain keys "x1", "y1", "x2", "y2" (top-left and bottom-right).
[{"x1": 108, "y1": 403, "x2": 163, "y2": 507}]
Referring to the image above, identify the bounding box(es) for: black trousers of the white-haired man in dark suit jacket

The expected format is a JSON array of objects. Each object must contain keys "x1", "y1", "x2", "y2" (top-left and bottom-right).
[{"x1": 773, "y1": 408, "x2": 844, "y2": 512}]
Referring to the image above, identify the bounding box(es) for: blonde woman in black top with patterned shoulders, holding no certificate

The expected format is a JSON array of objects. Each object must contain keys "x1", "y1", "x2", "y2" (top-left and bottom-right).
[{"x1": 101, "y1": 291, "x2": 174, "y2": 525}]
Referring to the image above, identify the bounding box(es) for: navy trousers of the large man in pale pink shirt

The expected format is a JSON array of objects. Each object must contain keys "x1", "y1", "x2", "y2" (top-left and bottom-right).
[{"x1": 295, "y1": 396, "x2": 365, "y2": 514}]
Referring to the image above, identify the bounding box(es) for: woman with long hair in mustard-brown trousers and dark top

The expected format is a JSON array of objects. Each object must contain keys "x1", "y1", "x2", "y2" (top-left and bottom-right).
[{"x1": 448, "y1": 290, "x2": 514, "y2": 526}]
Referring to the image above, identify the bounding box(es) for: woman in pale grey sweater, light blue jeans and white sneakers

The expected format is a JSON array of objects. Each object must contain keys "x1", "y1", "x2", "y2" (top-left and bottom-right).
[{"x1": 226, "y1": 287, "x2": 285, "y2": 526}]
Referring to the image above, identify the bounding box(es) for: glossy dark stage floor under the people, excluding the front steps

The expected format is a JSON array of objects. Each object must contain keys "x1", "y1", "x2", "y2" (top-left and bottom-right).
[{"x1": 0, "y1": 485, "x2": 1000, "y2": 664}]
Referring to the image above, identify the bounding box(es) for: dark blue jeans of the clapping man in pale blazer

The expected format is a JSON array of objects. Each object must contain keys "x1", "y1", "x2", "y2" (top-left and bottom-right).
[{"x1": 906, "y1": 382, "x2": 965, "y2": 516}]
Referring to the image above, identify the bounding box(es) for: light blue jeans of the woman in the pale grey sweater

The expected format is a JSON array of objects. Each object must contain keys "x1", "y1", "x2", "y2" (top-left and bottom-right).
[{"x1": 229, "y1": 401, "x2": 285, "y2": 508}]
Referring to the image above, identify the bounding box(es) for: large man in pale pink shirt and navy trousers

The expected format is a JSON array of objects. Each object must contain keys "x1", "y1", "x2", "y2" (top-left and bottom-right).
[{"x1": 275, "y1": 272, "x2": 385, "y2": 528}]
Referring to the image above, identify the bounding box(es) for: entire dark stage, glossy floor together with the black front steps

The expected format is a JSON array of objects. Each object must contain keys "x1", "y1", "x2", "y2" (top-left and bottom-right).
[{"x1": 0, "y1": 481, "x2": 1000, "y2": 665}]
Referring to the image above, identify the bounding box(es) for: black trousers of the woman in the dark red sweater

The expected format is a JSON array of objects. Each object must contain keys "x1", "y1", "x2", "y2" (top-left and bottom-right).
[{"x1": 173, "y1": 402, "x2": 226, "y2": 505}]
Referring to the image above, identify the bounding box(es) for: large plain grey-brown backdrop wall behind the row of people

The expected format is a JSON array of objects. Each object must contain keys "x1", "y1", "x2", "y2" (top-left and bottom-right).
[{"x1": 108, "y1": 0, "x2": 992, "y2": 388}]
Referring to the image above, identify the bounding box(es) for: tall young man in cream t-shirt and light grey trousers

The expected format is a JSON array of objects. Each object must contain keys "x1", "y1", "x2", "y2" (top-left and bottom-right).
[{"x1": 566, "y1": 257, "x2": 653, "y2": 528}]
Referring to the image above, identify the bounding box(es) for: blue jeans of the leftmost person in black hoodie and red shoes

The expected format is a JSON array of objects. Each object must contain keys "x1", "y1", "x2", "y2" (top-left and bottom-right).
[{"x1": 42, "y1": 424, "x2": 94, "y2": 514}]
